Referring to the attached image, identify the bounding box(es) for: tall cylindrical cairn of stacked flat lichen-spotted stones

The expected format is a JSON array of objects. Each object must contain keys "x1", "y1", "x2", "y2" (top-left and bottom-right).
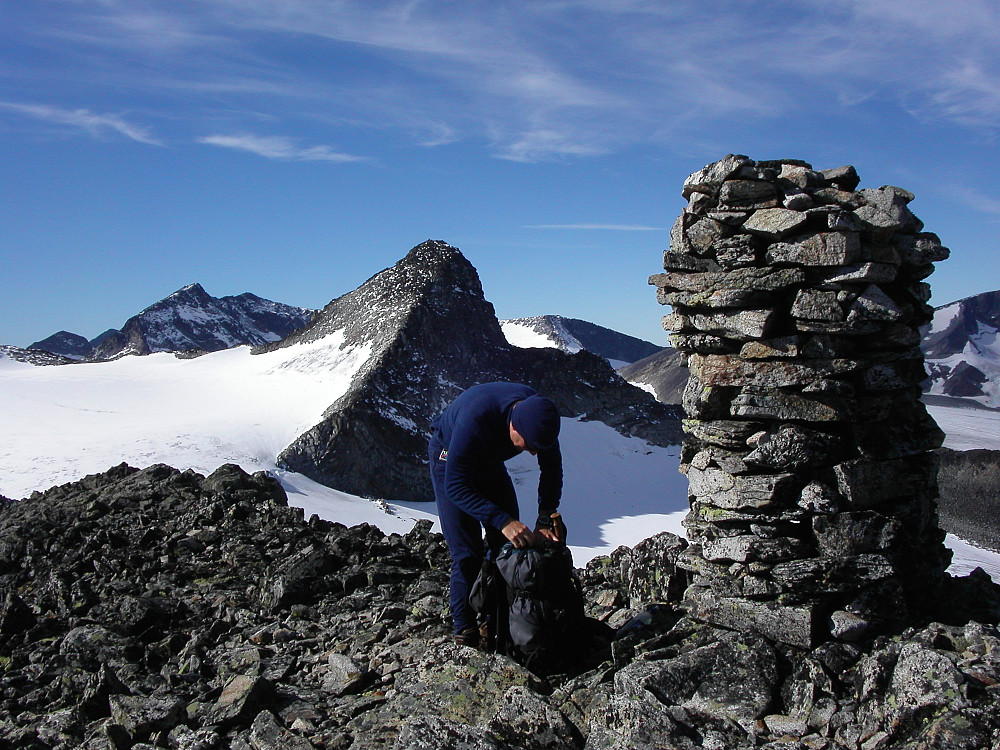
[{"x1": 650, "y1": 155, "x2": 950, "y2": 648}]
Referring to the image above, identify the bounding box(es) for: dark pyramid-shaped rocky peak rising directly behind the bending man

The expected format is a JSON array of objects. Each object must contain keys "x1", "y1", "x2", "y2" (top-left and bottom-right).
[{"x1": 266, "y1": 240, "x2": 680, "y2": 500}]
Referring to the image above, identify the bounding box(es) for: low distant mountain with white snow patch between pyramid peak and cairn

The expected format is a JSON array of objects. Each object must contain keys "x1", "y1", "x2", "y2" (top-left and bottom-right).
[{"x1": 500, "y1": 315, "x2": 663, "y2": 369}]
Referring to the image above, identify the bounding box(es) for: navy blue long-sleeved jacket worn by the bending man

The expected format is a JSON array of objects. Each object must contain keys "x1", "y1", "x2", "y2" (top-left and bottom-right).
[{"x1": 431, "y1": 383, "x2": 562, "y2": 529}]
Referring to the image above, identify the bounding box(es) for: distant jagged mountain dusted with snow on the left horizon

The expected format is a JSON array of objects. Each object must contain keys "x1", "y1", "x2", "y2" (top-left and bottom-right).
[{"x1": 29, "y1": 284, "x2": 315, "y2": 361}]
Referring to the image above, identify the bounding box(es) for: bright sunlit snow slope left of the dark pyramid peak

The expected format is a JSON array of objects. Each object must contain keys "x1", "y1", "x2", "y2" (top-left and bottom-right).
[{"x1": 0, "y1": 334, "x2": 369, "y2": 498}]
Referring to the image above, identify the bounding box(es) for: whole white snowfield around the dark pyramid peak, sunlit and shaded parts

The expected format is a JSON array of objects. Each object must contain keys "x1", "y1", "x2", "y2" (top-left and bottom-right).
[{"x1": 0, "y1": 346, "x2": 1000, "y2": 581}]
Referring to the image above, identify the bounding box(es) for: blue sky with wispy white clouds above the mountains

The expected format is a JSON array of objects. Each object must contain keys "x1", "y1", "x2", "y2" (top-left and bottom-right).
[{"x1": 0, "y1": 0, "x2": 1000, "y2": 346}]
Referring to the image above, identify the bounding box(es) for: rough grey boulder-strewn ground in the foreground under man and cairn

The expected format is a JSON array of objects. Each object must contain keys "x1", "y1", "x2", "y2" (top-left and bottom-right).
[{"x1": 0, "y1": 465, "x2": 1000, "y2": 750}]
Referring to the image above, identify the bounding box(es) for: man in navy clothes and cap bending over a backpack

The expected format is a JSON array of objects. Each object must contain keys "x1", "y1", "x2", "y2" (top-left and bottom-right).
[{"x1": 428, "y1": 383, "x2": 565, "y2": 646}]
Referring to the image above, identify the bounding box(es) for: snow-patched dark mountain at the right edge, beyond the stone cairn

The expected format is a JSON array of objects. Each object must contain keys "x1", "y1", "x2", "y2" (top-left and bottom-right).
[{"x1": 921, "y1": 291, "x2": 1000, "y2": 408}]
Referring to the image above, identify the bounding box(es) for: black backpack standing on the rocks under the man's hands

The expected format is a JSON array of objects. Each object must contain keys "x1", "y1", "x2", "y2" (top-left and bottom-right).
[{"x1": 470, "y1": 543, "x2": 588, "y2": 674}]
